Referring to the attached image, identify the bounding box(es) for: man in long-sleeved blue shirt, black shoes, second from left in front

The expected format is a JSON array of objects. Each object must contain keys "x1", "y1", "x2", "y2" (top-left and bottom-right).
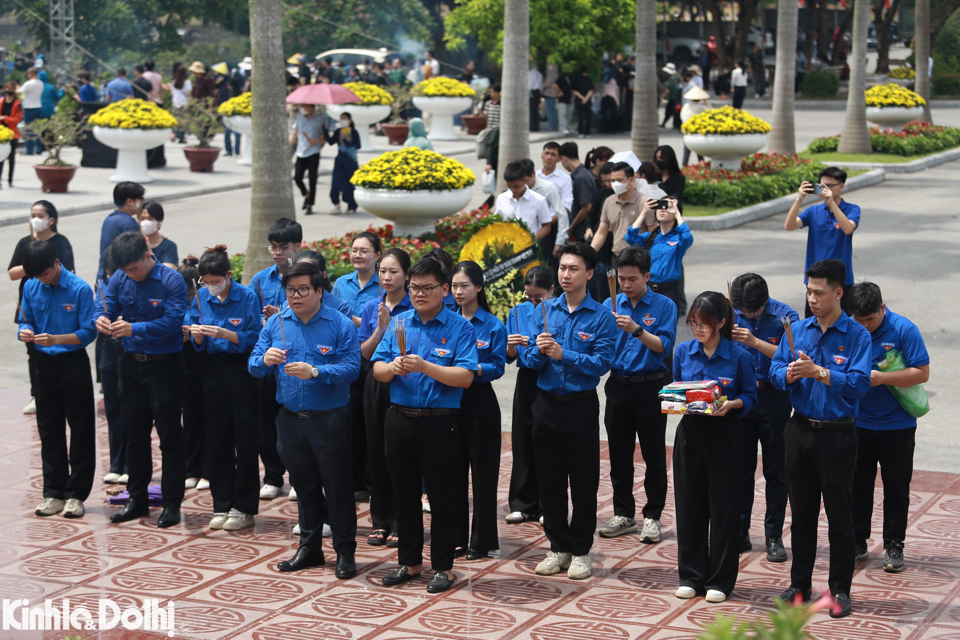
[{"x1": 96, "y1": 231, "x2": 187, "y2": 528}]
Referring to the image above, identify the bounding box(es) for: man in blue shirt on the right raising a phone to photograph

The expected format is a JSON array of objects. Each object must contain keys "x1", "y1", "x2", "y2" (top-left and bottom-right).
[{"x1": 783, "y1": 167, "x2": 860, "y2": 318}]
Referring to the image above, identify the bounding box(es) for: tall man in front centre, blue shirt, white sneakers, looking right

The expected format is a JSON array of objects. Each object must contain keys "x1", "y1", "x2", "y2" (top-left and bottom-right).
[{"x1": 524, "y1": 242, "x2": 621, "y2": 580}]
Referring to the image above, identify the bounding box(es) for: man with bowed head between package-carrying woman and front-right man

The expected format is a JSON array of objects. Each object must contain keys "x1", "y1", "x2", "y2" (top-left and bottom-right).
[{"x1": 730, "y1": 273, "x2": 800, "y2": 562}]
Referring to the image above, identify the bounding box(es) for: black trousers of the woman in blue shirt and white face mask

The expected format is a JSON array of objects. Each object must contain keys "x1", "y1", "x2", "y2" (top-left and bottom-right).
[{"x1": 203, "y1": 353, "x2": 260, "y2": 514}]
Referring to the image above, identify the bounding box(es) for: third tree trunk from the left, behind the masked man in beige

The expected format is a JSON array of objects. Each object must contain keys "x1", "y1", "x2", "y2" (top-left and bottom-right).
[{"x1": 630, "y1": 0, "x2": 656, "y2": 161}]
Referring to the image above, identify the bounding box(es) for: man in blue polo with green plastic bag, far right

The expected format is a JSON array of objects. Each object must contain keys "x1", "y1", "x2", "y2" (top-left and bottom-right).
[{"x1": 848, "y1": 282, "x2": 930, "y2": 573}]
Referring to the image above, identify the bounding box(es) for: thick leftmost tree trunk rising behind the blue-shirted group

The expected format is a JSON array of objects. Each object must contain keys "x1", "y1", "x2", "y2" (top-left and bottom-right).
[{"x1": 243, "y1": 0, "x2": 296, "y2": 284}]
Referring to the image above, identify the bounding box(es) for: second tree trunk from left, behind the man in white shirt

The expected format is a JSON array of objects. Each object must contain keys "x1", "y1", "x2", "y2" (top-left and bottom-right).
[{"x1": 497, "y1": 0, "x2": 530, "y2": 193}]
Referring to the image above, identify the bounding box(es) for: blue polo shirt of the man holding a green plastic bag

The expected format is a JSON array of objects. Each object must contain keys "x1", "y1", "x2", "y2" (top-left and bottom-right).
[{"x1": 857, "y1": 307, "x2": 930, "y2": 431}]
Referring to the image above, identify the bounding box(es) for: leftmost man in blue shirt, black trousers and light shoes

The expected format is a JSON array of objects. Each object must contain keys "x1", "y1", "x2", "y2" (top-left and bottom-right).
[{"x1": 19, "y1": 240, "x2": 96, "y2": 518}]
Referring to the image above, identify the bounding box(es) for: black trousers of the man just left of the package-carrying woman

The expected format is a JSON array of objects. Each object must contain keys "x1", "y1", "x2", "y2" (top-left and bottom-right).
[{"x1": 603, "y1": 377, "x2": 667, "y2": 520}]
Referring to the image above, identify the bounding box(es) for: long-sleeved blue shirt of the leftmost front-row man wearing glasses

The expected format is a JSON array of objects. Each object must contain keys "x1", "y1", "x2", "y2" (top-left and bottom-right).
[{"x1": 247, "y1": 304, "x2": 360, "y2": 411}]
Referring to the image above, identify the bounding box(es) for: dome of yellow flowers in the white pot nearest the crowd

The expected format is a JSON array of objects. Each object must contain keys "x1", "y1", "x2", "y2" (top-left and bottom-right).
[{"x1": 350, "y1": 147, "x2": 477, "y2": 191}]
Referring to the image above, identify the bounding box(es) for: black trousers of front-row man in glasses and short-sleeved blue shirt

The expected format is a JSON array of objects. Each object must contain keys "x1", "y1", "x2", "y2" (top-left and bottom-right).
[{"x1": 384, "y1": 409, "x2": 457, "y2": 571}]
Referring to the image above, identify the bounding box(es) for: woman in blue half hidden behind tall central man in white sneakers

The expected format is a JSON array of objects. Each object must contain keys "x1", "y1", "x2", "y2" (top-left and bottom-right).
[{"x1": 504, "y1": 266, "x2": 553, "y2": 524}]
